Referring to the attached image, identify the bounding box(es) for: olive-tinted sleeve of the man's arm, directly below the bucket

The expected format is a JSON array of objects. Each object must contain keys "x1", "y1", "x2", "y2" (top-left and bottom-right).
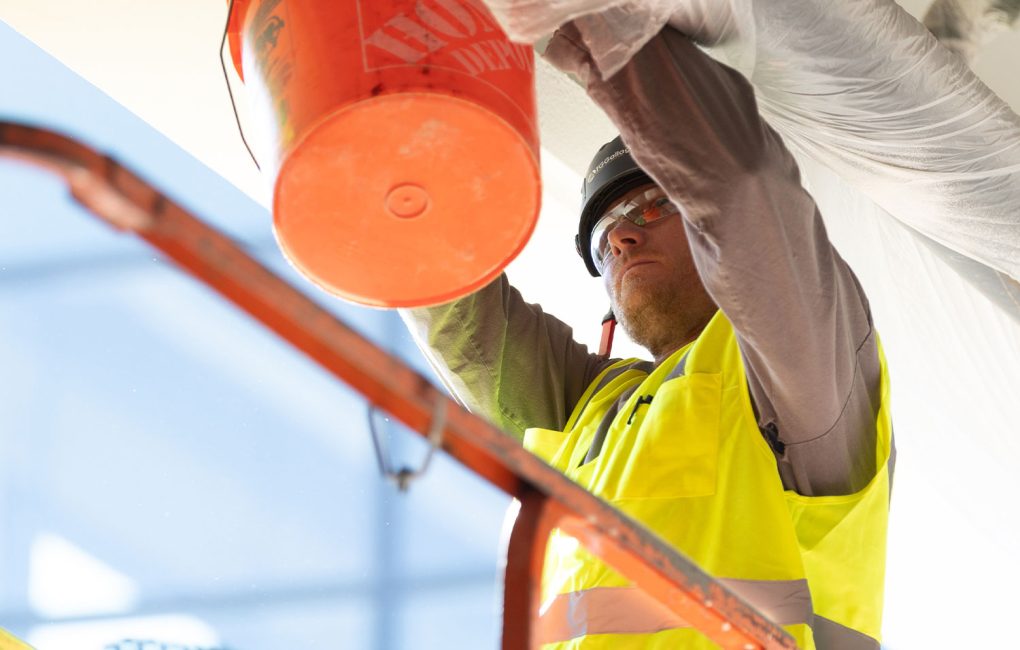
[{"x1": 401, "y1": 274, "x2": 611, "y2": 439}]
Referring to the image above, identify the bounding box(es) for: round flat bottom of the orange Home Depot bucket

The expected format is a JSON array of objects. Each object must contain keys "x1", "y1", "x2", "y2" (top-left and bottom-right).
[{"x1": 273, "y1": 93, "x2": 541, "y2": 307}]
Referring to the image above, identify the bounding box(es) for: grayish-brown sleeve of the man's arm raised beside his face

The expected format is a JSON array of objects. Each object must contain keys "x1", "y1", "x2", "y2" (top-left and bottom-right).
[{"x1": 546, "y1": 21, "x2": 880, "y2": 496}]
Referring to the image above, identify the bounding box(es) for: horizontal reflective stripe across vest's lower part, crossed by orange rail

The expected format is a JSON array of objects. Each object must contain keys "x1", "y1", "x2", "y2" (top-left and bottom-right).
[{"x1": 539, "y1": 579, "x2": 807, "y2": 648}]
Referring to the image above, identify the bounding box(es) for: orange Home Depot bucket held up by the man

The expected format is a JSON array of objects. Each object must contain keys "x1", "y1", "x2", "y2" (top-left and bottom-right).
[{"x1": 227, "y1": 0, "x2": 541, "y2": 307}]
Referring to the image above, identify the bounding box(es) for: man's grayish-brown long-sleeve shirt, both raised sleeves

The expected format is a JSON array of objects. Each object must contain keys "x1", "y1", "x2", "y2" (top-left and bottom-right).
[{"x1": 403, "y1": 23, "x2": 880, "y2": 496}]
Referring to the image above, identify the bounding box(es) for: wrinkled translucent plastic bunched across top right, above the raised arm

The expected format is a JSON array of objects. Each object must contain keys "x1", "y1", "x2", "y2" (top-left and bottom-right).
[{"x1": 489, "y1": 0, "x2": 1020, "y2": 279}]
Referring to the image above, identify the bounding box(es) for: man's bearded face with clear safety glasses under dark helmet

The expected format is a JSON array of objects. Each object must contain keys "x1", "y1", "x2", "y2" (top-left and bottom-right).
[{"x1": 602, "y1": 185, "x2": 715, "y2": 358}]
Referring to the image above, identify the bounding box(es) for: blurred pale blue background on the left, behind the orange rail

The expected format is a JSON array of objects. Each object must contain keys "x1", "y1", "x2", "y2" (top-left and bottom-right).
[{"x1": 0, "y1": 16, "x2": 518, "y2": 650}]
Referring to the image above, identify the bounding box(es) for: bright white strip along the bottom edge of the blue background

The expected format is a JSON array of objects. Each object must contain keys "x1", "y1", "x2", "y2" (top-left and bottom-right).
[{"x1": 27, "y1": 614, "x2": 219, "y2": 650}]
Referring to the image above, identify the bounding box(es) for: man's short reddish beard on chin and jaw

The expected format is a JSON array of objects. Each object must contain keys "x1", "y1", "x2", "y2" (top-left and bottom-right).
[{"x1": 612, "y1": 283, "x2": 692, "y2": 359}]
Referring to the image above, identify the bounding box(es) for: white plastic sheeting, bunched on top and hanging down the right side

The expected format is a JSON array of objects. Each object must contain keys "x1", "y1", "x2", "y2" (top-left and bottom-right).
[{"x1": 487, "y1": 0, "x2": 1020, "y2": 647}]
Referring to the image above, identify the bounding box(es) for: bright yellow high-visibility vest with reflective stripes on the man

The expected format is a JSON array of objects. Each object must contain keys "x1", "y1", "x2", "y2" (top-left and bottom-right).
[{"x1": 524, "y1": 311, "x2": 891, "y2": 650}]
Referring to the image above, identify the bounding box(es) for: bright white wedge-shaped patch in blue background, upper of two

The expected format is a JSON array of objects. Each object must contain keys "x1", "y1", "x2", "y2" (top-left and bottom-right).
[{"x1": 29, "y1": 533, "x2": 138, "y2": 618}]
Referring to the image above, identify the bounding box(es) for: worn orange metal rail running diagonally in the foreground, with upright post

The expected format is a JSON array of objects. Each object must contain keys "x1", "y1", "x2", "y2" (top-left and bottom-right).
[{"x1": 0, "y1": 121, "x2": 797, "y2": 650}]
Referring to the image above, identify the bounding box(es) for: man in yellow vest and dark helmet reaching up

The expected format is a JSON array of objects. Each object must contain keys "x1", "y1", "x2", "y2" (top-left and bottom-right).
[{"x1": 405, "y1": 17, "x2": 891, "y2": 649}]
